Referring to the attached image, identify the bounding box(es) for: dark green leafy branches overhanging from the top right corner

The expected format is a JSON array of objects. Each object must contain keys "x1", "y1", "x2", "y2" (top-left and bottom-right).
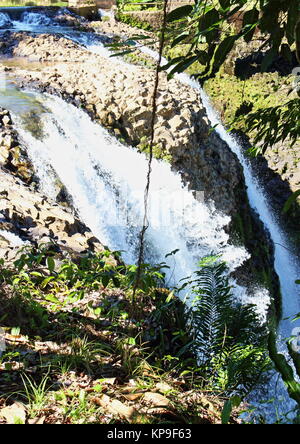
[{"x1": 168, "y1": 0, "x2": 300, "y2": 81}]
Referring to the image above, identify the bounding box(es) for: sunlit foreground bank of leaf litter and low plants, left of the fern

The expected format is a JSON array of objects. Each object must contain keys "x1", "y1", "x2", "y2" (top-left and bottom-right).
[{"x1": 0, "y1": 241, "x2": 247, "y2": 426}]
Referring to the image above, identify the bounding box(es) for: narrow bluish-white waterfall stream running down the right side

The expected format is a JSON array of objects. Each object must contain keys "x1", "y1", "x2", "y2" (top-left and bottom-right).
[{"x1": 129, "y1": 46, "x2": 300, "y2": 422}]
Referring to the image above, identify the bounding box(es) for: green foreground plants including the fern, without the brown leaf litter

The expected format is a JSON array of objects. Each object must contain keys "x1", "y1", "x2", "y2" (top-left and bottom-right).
[{"x1": 0, "y1": 248, "x2": 276, "y2": 422}]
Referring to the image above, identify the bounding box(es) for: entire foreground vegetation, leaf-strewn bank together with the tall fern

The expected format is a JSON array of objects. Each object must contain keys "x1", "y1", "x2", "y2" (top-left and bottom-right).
[{"x1": 0, "y1": 245, "x2": 276, "y2": 424}]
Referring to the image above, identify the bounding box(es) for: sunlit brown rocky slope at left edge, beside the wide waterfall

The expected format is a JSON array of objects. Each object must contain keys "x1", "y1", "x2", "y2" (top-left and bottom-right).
[{"x1": 0, "y1": 108, "x2": 104, "y2": 260}]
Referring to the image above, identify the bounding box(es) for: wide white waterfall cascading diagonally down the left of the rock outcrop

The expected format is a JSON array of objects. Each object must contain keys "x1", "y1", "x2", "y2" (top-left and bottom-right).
[{"x1": 2, "y1": 91, "x2": 269, "y2": 320}]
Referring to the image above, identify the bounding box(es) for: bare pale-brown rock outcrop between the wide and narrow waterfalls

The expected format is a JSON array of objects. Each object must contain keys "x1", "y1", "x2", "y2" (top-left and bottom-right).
[{"x1": 1, "y1": 33, "x2": 245, "y2": 215}]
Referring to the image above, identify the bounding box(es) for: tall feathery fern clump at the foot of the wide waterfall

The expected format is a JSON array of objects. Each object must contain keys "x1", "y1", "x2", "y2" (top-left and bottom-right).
[{"x1": 185, "y1": 261, "x2": 269, "y2": 393}]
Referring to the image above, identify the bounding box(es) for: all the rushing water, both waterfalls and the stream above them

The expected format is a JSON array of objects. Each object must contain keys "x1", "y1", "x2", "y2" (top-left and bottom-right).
[{"x1": 0, "y1": 8, "x2": 300, "y2": 422}]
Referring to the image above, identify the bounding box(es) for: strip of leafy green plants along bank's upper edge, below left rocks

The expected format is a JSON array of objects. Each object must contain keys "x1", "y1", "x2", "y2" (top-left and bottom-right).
[{"x1": 0, "y1": 245, "x2": 167, "y2": 302}]
